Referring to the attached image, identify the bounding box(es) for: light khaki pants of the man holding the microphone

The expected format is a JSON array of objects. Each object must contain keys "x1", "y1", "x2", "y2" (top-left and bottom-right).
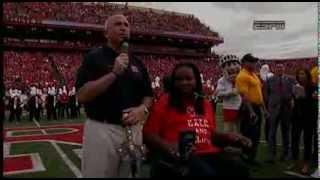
[{"x1": 82, "y1": 119, "x2": 142, "y2": 178}]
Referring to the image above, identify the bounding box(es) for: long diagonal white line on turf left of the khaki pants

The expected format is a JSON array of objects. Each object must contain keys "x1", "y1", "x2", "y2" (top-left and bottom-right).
[{"x1": 33, "y1": 120, "x2": 82, "y2": 178}]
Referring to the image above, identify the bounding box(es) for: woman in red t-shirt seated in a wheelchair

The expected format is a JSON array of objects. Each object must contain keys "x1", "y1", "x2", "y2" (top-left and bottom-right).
[{"x1": 143, "y1": 63, "x2": 251, "y2": 177}]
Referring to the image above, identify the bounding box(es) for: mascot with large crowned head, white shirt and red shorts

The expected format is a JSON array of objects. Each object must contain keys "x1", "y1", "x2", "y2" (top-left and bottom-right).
[{"x1": 215, "y1": 55, "x2": 242, "y2": 132}]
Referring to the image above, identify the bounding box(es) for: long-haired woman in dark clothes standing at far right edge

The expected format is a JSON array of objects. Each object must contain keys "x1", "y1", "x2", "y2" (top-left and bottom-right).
[{"x1": 289, "y1": 68, "x2": 317, "y2": 175}]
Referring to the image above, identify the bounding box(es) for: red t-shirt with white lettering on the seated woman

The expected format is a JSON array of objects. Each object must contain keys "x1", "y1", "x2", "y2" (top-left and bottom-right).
[{"x1": 143, "y1": 95, "x2": 221, "y2": 154}]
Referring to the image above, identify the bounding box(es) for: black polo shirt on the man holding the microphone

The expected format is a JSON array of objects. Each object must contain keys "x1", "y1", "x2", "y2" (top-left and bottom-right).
[{"x1": 76, "y1": 46, "x2": 153, "y2": 124}]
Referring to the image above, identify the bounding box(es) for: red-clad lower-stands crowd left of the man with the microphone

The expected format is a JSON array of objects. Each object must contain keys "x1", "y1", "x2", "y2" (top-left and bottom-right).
[{"x1": 4, "y1": 51, "x2": 82, "y2": 88}]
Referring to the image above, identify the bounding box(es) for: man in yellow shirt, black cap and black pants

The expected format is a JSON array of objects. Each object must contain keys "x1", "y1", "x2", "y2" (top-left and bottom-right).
[{"x1": 236, "y1": 54, "x2": 268, "y2": 166}]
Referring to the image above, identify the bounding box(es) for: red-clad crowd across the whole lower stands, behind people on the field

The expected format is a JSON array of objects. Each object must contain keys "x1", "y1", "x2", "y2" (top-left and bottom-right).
[{"x1": 4, "y1": 51, "x2": 316, "y2": 101}]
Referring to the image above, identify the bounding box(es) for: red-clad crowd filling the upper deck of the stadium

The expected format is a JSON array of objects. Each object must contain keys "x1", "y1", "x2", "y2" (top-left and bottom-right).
[{"x1": 3, "y1": 2, "x2": 218, "y2": 36}]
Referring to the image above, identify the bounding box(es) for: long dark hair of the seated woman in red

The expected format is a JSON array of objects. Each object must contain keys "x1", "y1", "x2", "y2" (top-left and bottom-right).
[{"x1": 169, "y1": 63, "x2": 204, "y2": 115}]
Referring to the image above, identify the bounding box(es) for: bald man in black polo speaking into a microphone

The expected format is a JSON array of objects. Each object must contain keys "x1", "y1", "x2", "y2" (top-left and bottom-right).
[{"x1": 76, "y1": 15, "x2": 153, "y2": 177}]
